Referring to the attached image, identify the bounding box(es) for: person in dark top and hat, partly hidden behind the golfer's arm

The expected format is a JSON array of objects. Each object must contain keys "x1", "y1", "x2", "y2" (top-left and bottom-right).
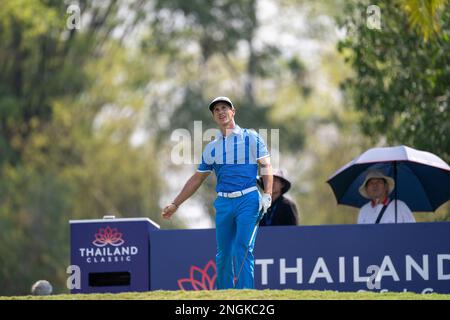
[{"x1": 258, "y1": 170, "x2": 298, "y2": 227}]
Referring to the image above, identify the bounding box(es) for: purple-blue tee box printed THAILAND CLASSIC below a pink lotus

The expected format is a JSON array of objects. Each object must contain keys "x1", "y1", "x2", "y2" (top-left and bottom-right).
[{"x1": 70, "y1": 218, "x2": 159, "y2": 293}]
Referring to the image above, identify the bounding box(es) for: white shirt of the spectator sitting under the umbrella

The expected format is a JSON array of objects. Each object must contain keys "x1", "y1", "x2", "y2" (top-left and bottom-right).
[{"x1": 358, "y1": 200, "x2": 416, "y2": 224}]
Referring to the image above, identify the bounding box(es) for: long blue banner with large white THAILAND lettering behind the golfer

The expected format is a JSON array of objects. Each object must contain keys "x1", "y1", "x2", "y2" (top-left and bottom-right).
[{"x1": 150, "y1": 222, "x2": 450, "y2": 293}]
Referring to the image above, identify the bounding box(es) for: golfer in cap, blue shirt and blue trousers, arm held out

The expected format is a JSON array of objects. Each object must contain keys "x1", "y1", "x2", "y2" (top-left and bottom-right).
[{"x1": 161, "y1": 97, "x2": 273, "y2": 289}]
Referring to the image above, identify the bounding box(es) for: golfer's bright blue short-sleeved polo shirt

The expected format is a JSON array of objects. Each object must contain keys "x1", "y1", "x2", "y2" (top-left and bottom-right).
[{"x1": 197, "y1": 125, "x2": 270, "y2": 192}]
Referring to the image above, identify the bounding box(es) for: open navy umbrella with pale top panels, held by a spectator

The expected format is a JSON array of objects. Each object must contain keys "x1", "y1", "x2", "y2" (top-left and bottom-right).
[{"x1": 327, "y1": 146, "x2": 450, "y2": 222}]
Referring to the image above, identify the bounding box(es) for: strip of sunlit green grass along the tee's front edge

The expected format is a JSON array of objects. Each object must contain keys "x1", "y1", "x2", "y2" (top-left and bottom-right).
[{"x1": 0, "y1": 290, "x2": 450, "y2": 300}]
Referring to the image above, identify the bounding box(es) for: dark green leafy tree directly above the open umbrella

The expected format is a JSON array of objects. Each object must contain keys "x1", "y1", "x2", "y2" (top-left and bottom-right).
[{"x1": 339, "y1": 1, "x2": 450, "y2": 162}]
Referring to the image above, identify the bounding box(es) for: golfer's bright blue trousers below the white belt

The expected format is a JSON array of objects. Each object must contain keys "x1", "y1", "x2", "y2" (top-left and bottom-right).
[{"x1": 214, "y1": 190, "x2": 260, "y2": 289}]
